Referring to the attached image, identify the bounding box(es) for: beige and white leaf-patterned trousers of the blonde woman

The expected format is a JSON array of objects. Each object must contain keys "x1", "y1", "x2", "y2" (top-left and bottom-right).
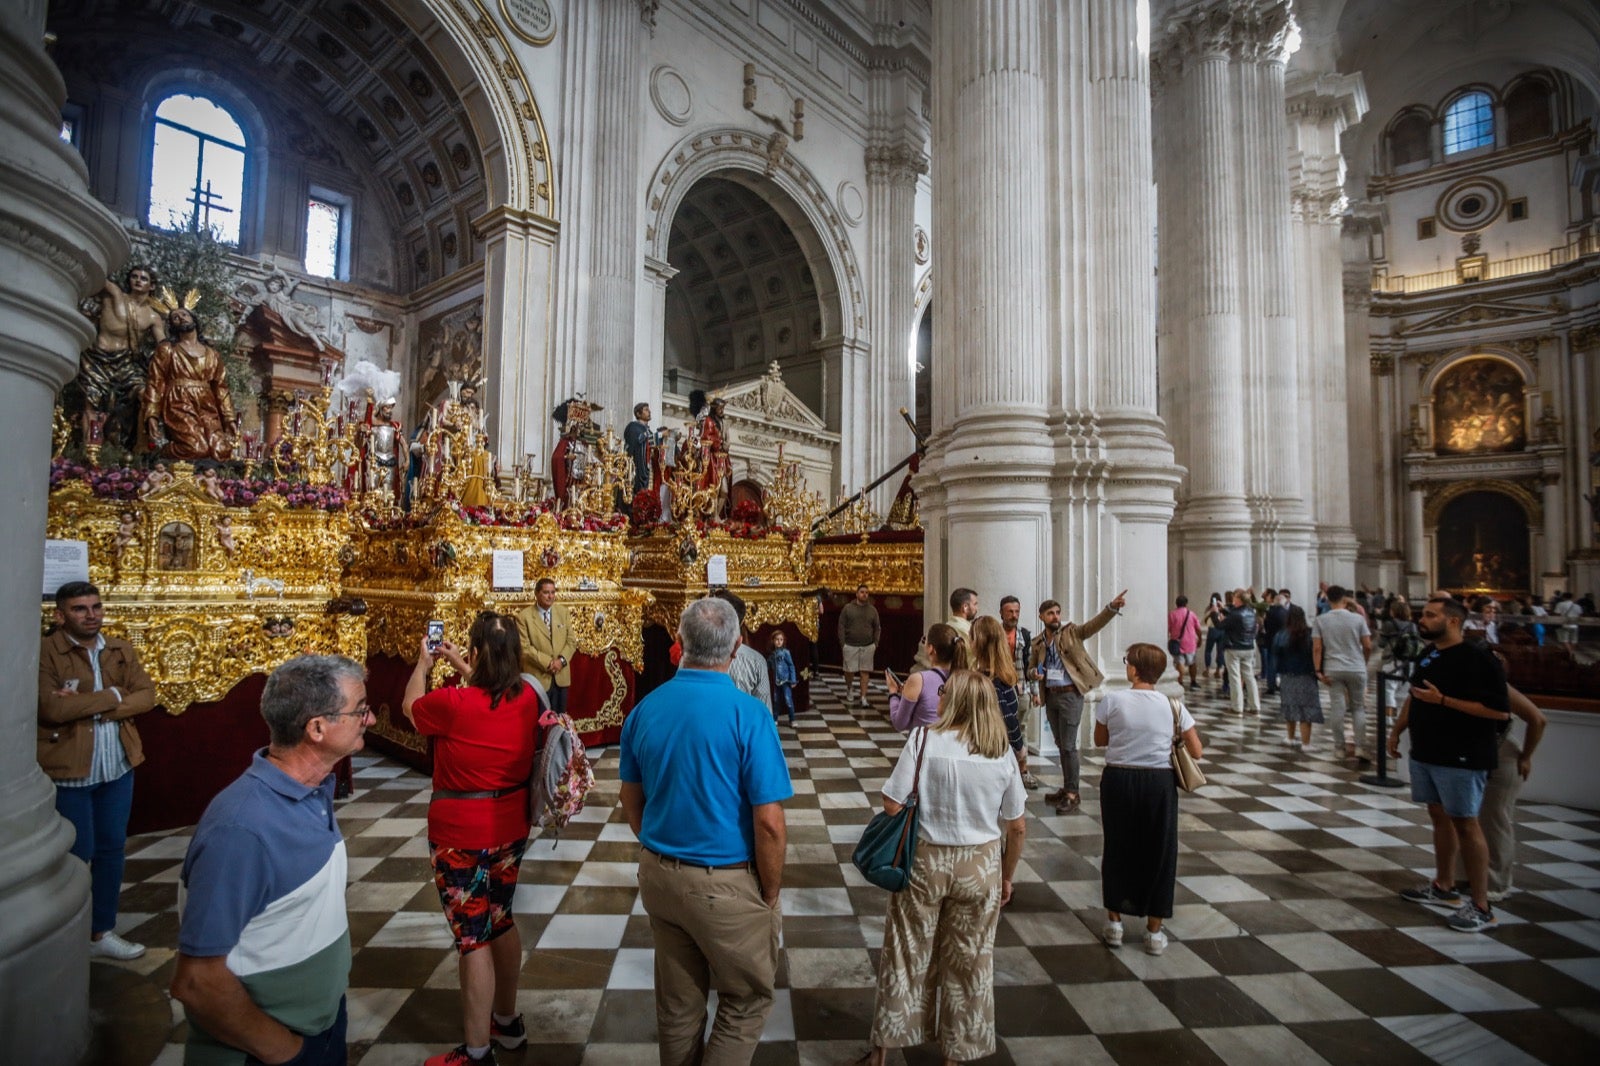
[{"x1": 872, "y1": 839, "x2": 1000, "y2": 1061}]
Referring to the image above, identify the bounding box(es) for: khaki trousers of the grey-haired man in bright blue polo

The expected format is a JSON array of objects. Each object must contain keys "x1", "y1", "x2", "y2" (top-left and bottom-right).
[{"x1": 638, "y1": 848, "x2": 782, "y2": 1066}]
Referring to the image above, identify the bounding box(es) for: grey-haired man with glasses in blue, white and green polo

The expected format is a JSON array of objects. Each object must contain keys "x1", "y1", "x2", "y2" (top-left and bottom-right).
[{"x1": 173, "y1": 655, "x2": 371, "y2": 1066}]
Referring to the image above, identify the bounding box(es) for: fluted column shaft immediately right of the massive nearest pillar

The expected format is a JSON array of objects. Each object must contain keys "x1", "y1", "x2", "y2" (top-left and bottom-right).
[{"x1": 1155, "y1": 8, "x2": 1253, "y2": 595}]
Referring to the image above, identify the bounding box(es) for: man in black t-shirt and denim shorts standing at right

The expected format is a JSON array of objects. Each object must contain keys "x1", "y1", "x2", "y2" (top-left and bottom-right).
[{"x1": 1389, "y1": 599, "x2": 1510, "y2": 933}]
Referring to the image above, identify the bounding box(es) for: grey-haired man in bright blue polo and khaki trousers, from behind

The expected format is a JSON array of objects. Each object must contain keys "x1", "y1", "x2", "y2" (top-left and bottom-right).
[{"x1": 621, "y1": 599, "x2": 794, "y2": 1066}]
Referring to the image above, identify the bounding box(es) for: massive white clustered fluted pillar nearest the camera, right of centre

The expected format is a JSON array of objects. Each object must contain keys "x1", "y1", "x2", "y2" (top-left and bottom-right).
[{"x1": 918, "y1": 0, "x2": 1171, "y2": 683}]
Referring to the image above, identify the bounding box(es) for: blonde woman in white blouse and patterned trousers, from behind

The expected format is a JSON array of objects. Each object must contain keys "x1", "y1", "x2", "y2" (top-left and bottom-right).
[{"x1": 858, "y1": 669, "x2": 1027, "y2": 1066}]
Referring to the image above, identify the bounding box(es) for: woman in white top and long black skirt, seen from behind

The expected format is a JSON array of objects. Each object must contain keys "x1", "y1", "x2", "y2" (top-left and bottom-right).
[{"x1": 1094, "y1": 643, "x2": 1200, "y2": 956}]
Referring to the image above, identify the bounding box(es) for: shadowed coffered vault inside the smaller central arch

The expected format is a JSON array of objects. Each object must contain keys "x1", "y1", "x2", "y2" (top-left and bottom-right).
[{"x1": 667, "y1": 171, "x2": 832, "y2": 410}]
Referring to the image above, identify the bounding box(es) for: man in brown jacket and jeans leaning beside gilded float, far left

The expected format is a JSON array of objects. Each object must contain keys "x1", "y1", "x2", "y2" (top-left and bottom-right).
[{"x1": 38, "y1": 581, "x2": 155, "y2": 959}]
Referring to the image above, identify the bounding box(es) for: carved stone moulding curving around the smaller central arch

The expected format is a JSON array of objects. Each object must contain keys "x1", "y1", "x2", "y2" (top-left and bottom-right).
[{"x1": 643, "y1": 127, "x2": 866, "y2": 343}]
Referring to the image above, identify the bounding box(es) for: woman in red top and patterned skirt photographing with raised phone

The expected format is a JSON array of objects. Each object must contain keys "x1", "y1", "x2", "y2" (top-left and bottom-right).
[{"x1": 402, "y1": 611, "x2": 541, "y2": 1066}]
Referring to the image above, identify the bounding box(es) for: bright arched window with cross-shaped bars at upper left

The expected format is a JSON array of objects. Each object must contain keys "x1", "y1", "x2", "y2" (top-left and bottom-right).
[{"x1": 147, "y1": 94, "x2": 245, "y2": 243}]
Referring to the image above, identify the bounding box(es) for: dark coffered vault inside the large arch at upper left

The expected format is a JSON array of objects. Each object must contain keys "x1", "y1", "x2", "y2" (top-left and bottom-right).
[{"x1": 50, "y1": 0, "x2": 507, "y2": 288}]
